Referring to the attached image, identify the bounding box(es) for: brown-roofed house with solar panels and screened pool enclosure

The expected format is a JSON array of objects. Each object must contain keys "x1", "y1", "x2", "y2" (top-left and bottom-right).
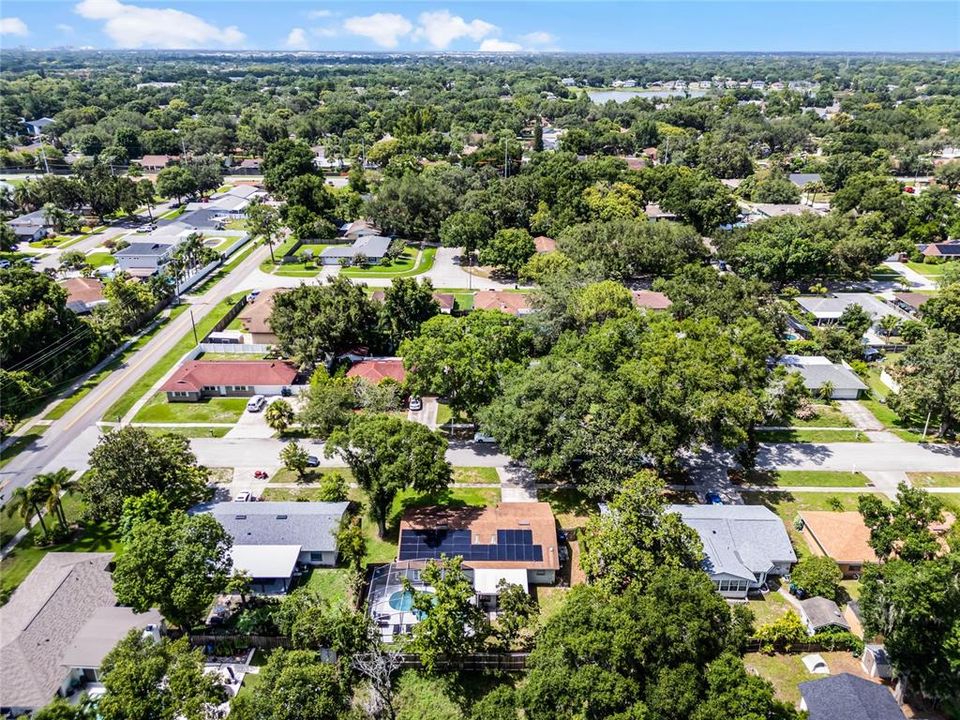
[{"x1": 367, "y1": 503, "x2": 560, "y2": 641}]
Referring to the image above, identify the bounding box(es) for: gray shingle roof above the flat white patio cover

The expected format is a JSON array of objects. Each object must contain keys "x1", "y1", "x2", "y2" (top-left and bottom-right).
[{"x1": 210, "y1": 502, "x2": 348, "y2": 552}]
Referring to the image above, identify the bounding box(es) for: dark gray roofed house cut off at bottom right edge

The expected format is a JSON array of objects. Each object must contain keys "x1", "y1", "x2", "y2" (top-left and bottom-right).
[{"x1": 798, "y1": 673, "x2": 906, "y2": 720}]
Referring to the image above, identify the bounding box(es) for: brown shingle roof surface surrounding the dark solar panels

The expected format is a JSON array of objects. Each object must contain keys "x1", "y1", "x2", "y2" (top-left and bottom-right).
[{"x1": 400, "y1": 502, "x2": 560, "y2": 570}]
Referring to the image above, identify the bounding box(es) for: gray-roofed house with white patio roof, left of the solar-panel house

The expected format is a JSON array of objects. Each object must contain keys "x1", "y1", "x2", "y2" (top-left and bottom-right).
[{"x1": 209, "y1": 501, "x2": 349, "y2": 592}]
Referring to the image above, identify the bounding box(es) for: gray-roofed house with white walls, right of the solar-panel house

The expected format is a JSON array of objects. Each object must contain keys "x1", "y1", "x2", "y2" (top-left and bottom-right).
[{"x1": 667, "y1": 505, "x2": 797, "y2": 598}]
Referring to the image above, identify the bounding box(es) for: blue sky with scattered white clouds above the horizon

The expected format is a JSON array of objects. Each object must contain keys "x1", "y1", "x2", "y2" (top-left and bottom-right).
[{"x1": 0, "y1": 0, "x2": 960, "y2": 53}]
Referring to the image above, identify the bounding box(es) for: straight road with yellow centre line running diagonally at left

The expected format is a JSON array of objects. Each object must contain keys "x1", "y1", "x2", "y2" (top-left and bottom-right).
[{"x1": 0, "y1": 242, "x2": 269, "y2": 501}]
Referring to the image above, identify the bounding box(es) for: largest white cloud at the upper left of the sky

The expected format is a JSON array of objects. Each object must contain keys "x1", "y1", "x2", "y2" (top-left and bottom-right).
[{"x1": 74, "y1": 0, "x2": 246, "y2": 49}]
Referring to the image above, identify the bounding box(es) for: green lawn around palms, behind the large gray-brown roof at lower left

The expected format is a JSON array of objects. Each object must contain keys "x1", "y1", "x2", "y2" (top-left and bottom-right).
[{"x1": 0, "y1": 496, "x2": 120, "y2": 602}]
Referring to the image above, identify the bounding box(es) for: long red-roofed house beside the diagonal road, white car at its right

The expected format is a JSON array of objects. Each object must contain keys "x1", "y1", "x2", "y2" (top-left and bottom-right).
[{"x1": 160, "y1": 360, "x2": 297, "y2": 402}]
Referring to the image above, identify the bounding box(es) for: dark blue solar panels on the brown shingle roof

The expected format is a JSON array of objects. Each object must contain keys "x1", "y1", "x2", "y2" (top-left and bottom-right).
[{"x1": 399, "y1": 530, "x2": 543, "y2": 562}]
